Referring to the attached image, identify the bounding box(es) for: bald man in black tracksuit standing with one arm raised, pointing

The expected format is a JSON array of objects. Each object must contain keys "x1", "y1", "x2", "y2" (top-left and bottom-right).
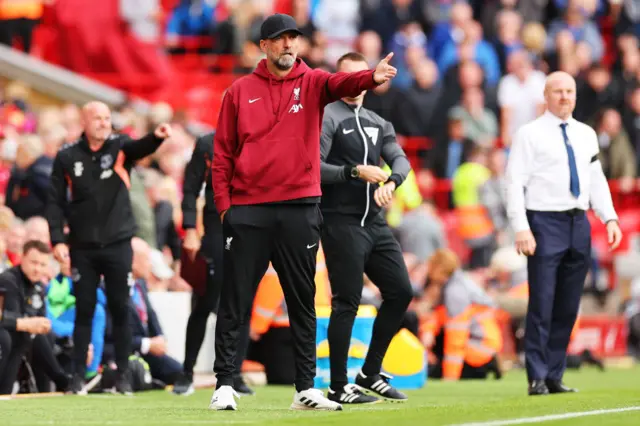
[{"x1": 46, "y1": 102, "x2": 171, "y2": 394}]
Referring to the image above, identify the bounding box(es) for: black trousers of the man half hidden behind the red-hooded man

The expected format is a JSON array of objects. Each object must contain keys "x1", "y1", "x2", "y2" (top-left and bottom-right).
[{"x1": 183, "y1": 216, "x2": 250, "y2": 377}]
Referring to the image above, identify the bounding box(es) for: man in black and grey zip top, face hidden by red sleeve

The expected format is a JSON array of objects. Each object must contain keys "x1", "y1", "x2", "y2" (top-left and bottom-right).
[{"x1": 320, "y1": 53, "x2": 412, "y2": 404}]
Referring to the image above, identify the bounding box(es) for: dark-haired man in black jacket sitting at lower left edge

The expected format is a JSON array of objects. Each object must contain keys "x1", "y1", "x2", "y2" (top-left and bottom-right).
[{"x1": 0, "y1": 241, "x2": 69, "y2": 395}]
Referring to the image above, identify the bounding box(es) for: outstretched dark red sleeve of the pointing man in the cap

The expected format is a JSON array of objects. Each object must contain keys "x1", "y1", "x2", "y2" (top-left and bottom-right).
[{"x1": 314, "y1": 69, "x2": 378, "y2": 105}]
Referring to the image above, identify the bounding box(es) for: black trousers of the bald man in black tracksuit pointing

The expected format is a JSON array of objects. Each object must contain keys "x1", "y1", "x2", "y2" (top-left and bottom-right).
[{"x1": 71, "y1": 239, "x2": 133, "y2": 377}]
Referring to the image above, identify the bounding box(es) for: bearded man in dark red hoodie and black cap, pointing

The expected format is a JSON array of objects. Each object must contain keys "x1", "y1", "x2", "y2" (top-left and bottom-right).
[{"x1": 209, "y1": 14, "x2": 396, "y2": 410}]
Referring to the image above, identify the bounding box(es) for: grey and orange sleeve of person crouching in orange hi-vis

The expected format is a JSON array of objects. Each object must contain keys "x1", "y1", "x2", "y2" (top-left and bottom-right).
[{"x1": 442, "y1": 280, "x2": 471, "y2": 379}]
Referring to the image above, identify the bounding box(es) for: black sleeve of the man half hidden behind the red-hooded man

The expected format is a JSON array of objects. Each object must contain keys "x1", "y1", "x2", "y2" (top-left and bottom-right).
[{"x1": 182, "y1": 137, "x2": 207, "y2": 229}]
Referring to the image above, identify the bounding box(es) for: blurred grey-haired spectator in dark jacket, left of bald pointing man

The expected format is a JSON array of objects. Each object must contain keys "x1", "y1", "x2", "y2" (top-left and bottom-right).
[{"x1": 5, "y1": 135, "x2": 53, "y2": 220}]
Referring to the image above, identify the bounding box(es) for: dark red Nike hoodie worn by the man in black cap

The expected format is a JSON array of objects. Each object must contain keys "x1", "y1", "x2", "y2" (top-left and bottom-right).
[{"x1": 211, "y1": 59, "x2": 377, "y2": 213}]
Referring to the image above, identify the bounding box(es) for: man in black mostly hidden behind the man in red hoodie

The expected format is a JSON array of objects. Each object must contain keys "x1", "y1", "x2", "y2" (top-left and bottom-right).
[{"x1": 173, "y1": 133, "x2": 253, "y2": 395}]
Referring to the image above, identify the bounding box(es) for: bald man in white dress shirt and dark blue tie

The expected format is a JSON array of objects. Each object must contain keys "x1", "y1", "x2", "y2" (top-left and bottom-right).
[{"x1": 507, "y1": 72, "x2": 622, "y2": 395}]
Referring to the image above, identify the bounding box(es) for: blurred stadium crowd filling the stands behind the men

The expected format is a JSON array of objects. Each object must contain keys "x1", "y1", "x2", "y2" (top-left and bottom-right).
[{"x1": 0, "y1": 0, "x2": 640, "y2": 393}]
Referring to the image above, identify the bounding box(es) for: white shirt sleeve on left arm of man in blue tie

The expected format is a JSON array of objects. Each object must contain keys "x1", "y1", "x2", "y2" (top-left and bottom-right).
[{"x1": 506, "y1": 126, "x2": 534, "y2": 232}]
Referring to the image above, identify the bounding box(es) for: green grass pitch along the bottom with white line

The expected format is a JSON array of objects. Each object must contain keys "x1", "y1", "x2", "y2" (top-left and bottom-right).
[{"x1": 0, "y1": 367, "x2": 640, "y2": 426}]
